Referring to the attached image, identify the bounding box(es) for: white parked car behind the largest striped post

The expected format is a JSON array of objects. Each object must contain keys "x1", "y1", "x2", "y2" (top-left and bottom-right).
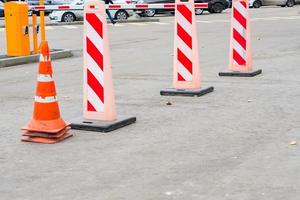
[{"x1": 49, "y1": 0, "x2": 133, "y2": 22}]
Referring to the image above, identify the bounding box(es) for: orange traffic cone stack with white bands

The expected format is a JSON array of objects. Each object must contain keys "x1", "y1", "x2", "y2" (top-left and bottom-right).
[{"x1": 21, "y1": 41, "x2": 72, "y2": 144}]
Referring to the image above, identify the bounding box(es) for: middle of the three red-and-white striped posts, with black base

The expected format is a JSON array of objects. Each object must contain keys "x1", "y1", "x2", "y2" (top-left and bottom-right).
[{"x1": 160, "y1": 0, "x2": 214, "y2": 96}]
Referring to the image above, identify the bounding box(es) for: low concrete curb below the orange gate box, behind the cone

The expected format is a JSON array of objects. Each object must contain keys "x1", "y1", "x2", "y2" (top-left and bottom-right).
[{"x1": 0, "y1": 49, "x2": 73, "y2": 68}]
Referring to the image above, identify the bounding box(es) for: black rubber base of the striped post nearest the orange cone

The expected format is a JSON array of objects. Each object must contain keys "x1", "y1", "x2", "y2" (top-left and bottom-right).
[{"x1": 71, "y1": 117, "x2": 136, "y2": 133}]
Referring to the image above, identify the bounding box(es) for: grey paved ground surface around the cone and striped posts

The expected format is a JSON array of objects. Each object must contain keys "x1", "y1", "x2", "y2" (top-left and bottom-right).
[{"x1": 0, "y1": 7, "x2": 300, "y2": 200}]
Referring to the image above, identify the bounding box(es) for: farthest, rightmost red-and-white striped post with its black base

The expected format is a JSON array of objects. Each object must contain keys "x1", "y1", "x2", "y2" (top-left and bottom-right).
[{"x1": 219, "y1": 0, "x2": 262, "y2": 77}]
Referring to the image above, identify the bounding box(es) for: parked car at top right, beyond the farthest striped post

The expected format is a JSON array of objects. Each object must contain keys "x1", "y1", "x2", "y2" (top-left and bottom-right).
[{"x1": 249, "y1": 0, "x2": 295, "y2": 8}]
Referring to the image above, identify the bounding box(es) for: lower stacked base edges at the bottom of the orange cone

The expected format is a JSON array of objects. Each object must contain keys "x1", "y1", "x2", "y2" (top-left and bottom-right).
[{"x1": 21, "y1": 130, "x2": 73, "y2": 144}]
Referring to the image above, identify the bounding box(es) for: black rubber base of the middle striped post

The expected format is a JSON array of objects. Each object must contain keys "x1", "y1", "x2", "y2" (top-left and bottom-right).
[{"x1": 160, "y1": 87, "x2": 214, "y2": 97}]
